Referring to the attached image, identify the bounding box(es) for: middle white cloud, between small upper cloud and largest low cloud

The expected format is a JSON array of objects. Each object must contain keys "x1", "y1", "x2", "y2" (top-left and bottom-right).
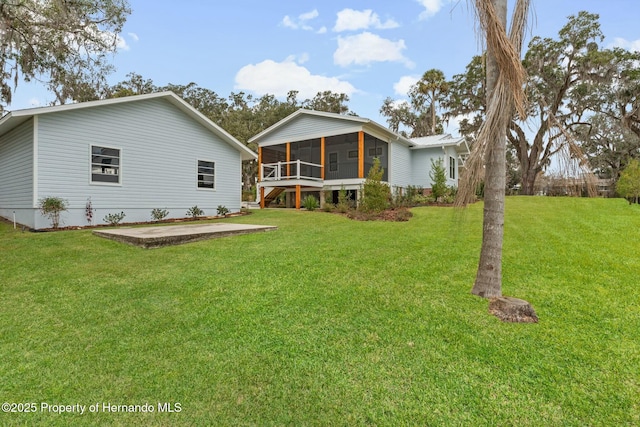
[{"x1": 333, "y1": 32, "x2": 415, "y2": 68}]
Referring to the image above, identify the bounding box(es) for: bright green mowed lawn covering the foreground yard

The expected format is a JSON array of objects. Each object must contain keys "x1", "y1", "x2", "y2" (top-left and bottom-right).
[{"x1": 0, "y1": 197, "x2": 640, "y2": 426}]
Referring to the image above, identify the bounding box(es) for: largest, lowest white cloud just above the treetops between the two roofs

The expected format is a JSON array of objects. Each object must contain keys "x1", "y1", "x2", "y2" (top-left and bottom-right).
[{"x1": 235, "y1": 56, "x2": 356, "y2": 99}]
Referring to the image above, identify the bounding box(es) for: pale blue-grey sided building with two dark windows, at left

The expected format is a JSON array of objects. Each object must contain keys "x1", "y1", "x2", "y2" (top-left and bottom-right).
[{"x1": 0, "y1": 92, "x2": 256, "y2": 229}]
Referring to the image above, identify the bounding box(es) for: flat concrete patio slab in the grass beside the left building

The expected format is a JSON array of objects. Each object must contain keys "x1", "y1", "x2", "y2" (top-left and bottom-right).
[{"x1": 93, "y1": 223, "x2": 278, "y2": 248}]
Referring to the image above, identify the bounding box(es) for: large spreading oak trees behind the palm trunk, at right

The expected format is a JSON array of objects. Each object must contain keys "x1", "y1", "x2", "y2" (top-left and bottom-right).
[{"x1": 380, "y1": 12, "x2": 640, "y2": 194}]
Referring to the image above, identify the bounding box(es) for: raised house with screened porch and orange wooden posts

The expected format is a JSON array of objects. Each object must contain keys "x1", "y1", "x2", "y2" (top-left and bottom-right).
[{"x1": 249, "y1": 109, "x2": 469, "y2": 208}]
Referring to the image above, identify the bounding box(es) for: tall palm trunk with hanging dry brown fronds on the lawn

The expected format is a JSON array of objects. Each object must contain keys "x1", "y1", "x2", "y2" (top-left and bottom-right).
[{"x1": 457, "y1": 0, "x2": 530, "y2": 298}]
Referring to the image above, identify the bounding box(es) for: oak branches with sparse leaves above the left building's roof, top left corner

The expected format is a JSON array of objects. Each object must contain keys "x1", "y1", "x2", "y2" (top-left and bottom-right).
[{"x1": 0, "y1": 0, "x2": 131, "y2": 108}]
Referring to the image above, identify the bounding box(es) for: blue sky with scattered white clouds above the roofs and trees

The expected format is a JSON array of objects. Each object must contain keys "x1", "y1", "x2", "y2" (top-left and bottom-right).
[{"x1": 8, "y1": 0, "x2": 640, "y2": 133}]
